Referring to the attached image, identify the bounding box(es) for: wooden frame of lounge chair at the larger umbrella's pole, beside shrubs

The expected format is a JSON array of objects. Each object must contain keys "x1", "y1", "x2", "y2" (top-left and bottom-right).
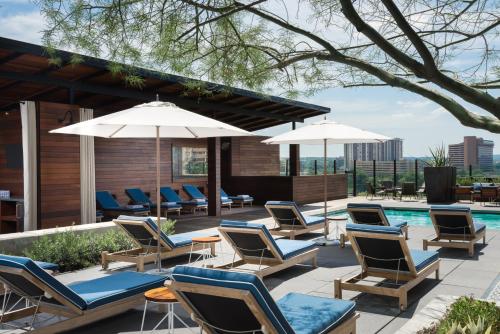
[{"x1": 101, "y1": 219, "x2": 215, "y2": 272}]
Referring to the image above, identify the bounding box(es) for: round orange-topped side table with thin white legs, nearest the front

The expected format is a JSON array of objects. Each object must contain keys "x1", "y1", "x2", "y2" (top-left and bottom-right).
[{"x1": 141, "y1": 287, "x2": 194, "y2": 333}]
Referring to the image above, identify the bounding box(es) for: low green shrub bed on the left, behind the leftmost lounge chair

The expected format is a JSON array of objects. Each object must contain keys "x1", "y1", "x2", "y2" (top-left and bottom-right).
[{"x1": 23, "y1": 220, "x2": 175, "y2": 272}]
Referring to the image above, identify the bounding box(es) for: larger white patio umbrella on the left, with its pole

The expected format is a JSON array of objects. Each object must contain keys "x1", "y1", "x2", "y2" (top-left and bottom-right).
[{"x1": 50, "y1": 101, "x2": 253, "y2": 271}]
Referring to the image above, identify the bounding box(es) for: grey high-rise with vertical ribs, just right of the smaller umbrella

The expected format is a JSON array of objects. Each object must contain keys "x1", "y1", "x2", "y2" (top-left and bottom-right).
[{"x1": 344, "y1": 138, "x2": 403, "y2": 168}]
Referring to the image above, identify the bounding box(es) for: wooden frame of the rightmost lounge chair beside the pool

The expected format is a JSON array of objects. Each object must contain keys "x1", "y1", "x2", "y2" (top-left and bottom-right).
[{"x1": 423, "y1": 210, "x2": 486, "y2": 257}]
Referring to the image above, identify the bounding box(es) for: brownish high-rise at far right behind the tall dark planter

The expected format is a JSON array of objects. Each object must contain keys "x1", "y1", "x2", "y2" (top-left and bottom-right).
[{"x1": 448, "y1": 136, "x2": 495, "y2": 171}]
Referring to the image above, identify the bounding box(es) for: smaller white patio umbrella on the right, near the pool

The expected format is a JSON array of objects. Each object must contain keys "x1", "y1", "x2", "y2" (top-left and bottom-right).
[{"x1": 262, "y1": 119, "x2": 391, "y2": 244}]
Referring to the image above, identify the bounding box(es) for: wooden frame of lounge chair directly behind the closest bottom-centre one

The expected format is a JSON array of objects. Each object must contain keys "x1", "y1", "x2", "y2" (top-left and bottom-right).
[{"x1": 218, "y1": 227, "x2": 319, "y2": 277}]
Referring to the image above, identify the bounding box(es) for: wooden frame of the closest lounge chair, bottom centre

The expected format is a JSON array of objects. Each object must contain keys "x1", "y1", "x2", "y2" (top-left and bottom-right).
[{"x1": 169, "y1": 281, "x2": 359, "y2": 334}]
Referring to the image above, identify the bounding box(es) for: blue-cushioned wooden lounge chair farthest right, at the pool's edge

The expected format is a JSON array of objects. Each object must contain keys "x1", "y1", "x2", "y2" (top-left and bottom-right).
[{"x1": 423, "y1": 206, "x2": 486, "y2": 256}]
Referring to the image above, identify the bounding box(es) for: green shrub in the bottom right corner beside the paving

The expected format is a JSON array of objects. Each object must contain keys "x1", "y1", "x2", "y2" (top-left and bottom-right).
[{"x1": 418, "y1": 297, "x2": 500, "y2": 334}]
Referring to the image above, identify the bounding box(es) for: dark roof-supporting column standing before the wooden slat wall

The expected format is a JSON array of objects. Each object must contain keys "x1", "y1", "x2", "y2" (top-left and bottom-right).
[{"x1": 207, "y1": 138, "x2": 221, "y2": 216}]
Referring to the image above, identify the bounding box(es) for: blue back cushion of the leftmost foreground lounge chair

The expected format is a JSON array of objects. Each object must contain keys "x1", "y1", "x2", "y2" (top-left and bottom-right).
[{"x1": 0, "y1": 255, "x2": 87, "y2": 310}]
